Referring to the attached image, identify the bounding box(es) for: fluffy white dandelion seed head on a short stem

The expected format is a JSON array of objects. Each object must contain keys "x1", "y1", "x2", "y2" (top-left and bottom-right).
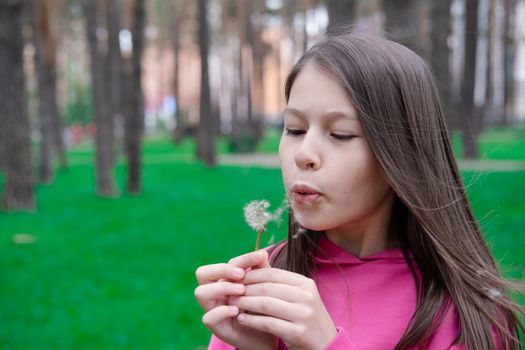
[{"x1": 244, "y1": 197, "x2": 288, "y2": 250}]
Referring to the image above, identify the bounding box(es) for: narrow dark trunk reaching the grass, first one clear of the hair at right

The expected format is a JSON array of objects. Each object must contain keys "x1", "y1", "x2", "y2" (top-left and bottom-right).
[{"x1": 461, "y1": 0, "x2": 478, "y2": 158}]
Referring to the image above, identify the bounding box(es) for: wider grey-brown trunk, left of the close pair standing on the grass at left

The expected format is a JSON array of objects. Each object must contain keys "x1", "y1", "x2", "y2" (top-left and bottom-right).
[{"x1": 83, "y1": 0, "x2": 116, "y2": 197}]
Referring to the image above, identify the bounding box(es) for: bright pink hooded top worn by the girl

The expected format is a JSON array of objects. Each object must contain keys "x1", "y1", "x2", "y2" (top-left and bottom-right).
[{"x1": 208, "y1": 237, "x2": 463, "y2": 350}]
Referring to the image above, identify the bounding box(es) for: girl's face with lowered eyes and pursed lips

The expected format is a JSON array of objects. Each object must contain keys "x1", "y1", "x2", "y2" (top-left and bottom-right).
[{"x1": 279, "y1": 63, "x2": 394, "y2": 238}]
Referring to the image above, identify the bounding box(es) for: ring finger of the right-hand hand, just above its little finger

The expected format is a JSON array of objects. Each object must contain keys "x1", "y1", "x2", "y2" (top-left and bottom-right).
[{"x1": 230, "y1": 296, "x2": 302, "y2": 322}]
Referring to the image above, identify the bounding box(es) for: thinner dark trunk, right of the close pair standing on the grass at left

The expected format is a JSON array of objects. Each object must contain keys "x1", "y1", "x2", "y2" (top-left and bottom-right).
[{"x1": 125, "y1": 0, "x2": 146, "y2": 194}]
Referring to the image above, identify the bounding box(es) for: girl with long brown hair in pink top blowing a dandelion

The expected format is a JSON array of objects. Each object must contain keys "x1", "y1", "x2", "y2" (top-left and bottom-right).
[{"x1": 195, "y1": 34, "x2": 523, "y2": 350}]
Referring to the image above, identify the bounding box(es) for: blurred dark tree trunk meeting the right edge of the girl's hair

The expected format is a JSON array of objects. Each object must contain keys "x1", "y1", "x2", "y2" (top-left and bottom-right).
[{"x1": 430, "y1": 0, "x2": 459, "y2": 129}]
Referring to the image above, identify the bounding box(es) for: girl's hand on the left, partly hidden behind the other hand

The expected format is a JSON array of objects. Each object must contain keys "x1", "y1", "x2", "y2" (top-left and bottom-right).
[{"x1": 195, "y1": 250, "x2": 277, "y2": 350}]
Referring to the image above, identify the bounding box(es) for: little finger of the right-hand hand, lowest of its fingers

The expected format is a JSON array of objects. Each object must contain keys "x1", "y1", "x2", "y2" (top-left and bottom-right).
[{"x1": 237, "y1": 313, "x2": 300, "y2": 339}]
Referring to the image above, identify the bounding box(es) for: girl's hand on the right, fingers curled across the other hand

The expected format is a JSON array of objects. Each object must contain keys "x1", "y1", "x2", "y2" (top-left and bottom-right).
[{"x1": 230, "y1": 268, "x2": 337, "y2": 350}]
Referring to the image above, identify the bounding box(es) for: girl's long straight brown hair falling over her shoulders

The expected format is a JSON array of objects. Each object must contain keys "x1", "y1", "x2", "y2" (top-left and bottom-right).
[{"x1": 272, "y1": 34, "x2": 524, "y2": 350}]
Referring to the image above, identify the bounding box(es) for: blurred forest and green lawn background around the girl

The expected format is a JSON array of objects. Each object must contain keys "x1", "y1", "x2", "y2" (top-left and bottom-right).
[{"x1": 0, "y1": 0, "x2": 525, "y2": 349}]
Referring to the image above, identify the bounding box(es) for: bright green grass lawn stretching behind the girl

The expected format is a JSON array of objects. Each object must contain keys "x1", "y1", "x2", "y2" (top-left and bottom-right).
[{"x1": 0, "y1": 135, "x2": 525, "y2": 349}]
